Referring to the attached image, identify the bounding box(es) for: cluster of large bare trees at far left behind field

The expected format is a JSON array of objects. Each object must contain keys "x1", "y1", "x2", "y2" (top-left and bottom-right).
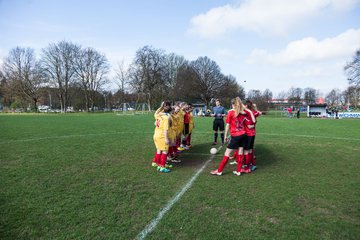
[{"x1": 0, "y1": 41, "x2": 110, "y2": 112}]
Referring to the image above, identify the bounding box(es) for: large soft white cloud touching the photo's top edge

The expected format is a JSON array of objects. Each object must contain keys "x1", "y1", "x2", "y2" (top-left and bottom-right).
[{"x1": 189, "y1": 0, "x2": 359, "y2": 38}]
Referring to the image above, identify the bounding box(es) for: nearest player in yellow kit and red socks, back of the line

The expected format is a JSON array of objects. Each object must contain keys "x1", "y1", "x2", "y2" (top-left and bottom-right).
[{"x1": 152, "y1": 102, "x2": 172, "y2": 173}]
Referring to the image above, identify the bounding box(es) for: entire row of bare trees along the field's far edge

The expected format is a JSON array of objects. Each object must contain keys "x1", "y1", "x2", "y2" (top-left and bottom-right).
[{"x1": 0, "y1": 41, "x2": 360, "y2": 112}]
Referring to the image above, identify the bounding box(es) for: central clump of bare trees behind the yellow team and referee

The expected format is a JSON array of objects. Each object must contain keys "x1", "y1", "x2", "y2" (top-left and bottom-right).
[{"x1": 122, "y1": 46, "x2": 244, "y2": 109}]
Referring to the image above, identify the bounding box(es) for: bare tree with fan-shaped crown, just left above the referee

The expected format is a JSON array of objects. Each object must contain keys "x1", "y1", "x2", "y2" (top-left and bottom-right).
[{"x1": 190, "y1": 57, "x2": 224, "y2": 104}]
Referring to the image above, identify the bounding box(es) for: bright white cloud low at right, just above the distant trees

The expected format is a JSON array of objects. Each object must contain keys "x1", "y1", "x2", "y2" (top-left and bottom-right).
[{"x1": 247, "y1": 29, "x2": 360, "y2": 65}]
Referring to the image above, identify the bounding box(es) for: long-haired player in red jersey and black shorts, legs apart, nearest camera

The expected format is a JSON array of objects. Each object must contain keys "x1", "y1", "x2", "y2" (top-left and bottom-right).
[{"x1": 210, "y1": 97, "x2": 252, "y2": 176}]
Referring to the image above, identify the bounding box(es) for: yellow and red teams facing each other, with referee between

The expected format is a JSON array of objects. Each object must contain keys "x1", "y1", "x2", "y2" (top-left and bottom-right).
[{"x1": 152, "y1": 97, "x2": 261, "y2": 176}]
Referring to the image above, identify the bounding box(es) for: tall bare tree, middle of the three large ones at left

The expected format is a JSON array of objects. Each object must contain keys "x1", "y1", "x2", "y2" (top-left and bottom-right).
[{"x1": 41, "y1": 41, "x2": 80, "y2": 112}]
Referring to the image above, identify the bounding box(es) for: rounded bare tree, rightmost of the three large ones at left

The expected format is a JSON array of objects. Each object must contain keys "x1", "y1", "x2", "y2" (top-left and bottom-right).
[{"x1": 74, "y1": 48, "x2": 109, "y2": 111}]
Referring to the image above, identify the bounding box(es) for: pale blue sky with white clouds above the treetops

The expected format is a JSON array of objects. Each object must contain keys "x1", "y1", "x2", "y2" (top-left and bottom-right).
[{"x1": 0, "y1": 0, "x2": 360, "y2": 97}]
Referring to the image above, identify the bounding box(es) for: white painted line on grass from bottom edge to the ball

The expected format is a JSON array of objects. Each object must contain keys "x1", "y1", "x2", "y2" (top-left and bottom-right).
[{"x1": 136, "y1": 146, "x2": 222, "y2": 240}]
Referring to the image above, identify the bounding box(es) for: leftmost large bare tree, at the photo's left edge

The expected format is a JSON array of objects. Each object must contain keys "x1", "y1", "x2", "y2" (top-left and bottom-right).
[{"x1": 3, "y1": 47, "x2": 44, "y2": 110}]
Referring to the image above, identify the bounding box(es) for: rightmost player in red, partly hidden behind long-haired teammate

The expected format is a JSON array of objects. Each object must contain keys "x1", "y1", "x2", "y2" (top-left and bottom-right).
[{"x1": 242, "y1": 100, "x2": 262, "y2": 172}]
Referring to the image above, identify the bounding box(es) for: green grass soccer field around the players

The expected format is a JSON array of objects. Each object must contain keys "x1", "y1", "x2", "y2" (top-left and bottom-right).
[{"x1": 0, "y1": 114, "x2": 360, "y2": 239}]
